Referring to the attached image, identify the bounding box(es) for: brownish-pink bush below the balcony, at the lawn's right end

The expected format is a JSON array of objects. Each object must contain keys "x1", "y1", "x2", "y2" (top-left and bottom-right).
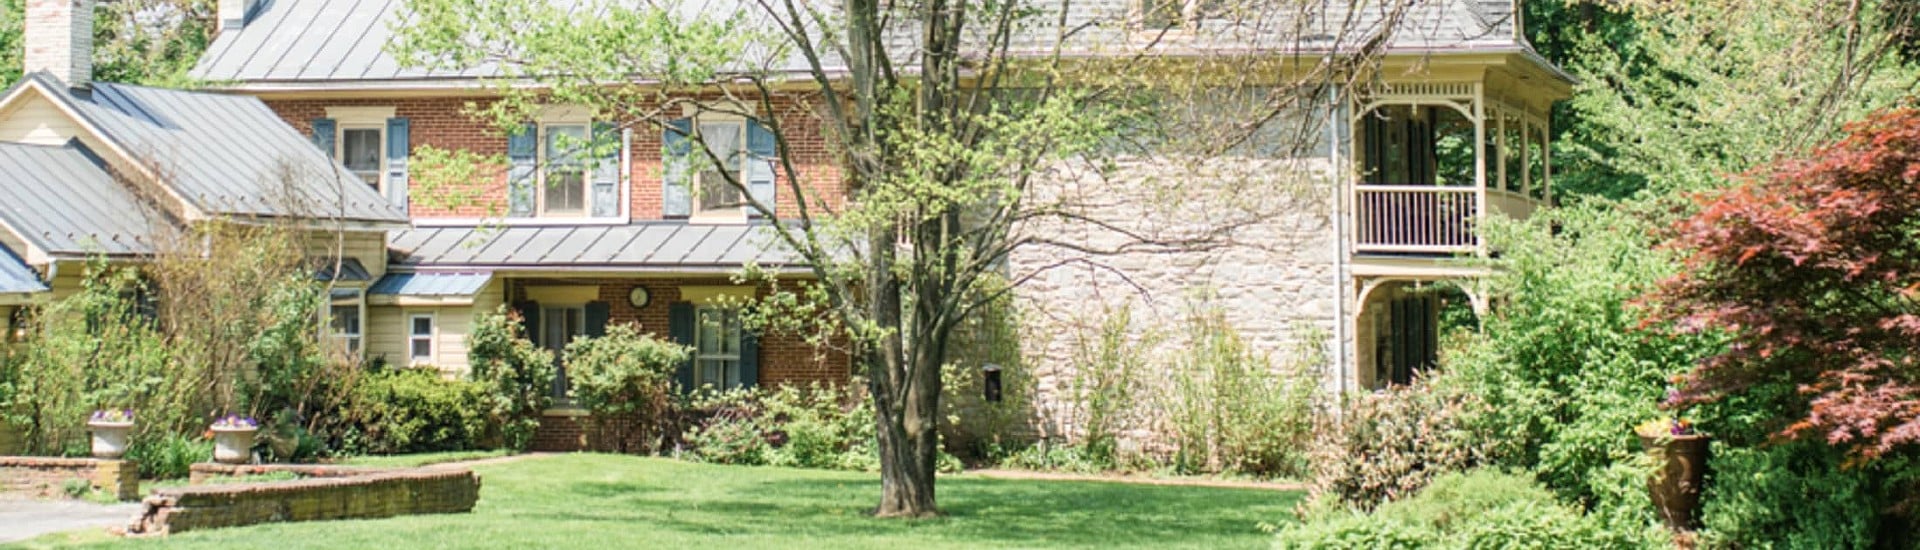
[{"x1": 1311, "y1": 381, "x2": 1484, "y2": 510}]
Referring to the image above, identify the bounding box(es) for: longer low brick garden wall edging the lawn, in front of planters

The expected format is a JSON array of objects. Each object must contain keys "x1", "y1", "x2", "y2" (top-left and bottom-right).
[{"x1": 127, "y1": 467, "x2": 480, "y2": 535}]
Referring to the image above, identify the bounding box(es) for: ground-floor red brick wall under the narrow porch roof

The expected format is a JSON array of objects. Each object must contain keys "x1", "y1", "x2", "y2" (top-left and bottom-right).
[{"x1": 507, "y1": 277, "x2": 851, "y2": 387}]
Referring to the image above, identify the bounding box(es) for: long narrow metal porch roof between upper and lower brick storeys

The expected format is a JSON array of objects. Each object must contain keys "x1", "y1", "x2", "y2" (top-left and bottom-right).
[{"x1": 388, "y1": 223, "x2": 804, "y2": 271}]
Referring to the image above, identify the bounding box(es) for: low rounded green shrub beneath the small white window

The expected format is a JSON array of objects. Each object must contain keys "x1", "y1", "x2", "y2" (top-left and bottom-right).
[{"x1": 351, "y1": 369, "x2": 488, "y2": 454}]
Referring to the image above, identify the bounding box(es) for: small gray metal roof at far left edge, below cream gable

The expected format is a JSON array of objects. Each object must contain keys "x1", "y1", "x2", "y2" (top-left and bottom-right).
[{"x1": 0, "y1": 142, "x2": 163, "y2": 256}]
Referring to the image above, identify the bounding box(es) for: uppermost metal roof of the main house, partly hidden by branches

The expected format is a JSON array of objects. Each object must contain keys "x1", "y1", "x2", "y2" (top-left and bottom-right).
[{"x1": 192, "y1": 0, "x2": 1530, "y2": 85}]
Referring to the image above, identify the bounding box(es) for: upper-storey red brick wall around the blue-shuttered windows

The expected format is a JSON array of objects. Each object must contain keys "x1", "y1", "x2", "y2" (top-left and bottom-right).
[{"x1": 267, "y1": 96, "x2": 847, "y2": 219}]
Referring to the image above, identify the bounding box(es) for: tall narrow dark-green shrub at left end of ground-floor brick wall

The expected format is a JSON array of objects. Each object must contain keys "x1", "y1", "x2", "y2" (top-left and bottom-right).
[{"x1": 467, "y1": 306, "x2": 555, "y2": 450}]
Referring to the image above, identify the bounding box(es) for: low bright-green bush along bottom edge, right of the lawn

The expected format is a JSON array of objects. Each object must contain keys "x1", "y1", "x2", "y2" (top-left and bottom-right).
[{"x1": 1277, "y1": 469, "x2": 1663, "y2": 548}]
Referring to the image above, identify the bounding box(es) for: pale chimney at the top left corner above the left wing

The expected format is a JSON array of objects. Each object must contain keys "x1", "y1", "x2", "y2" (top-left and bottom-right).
[{"x1": 21, "y1": 0, "x2": 94, "y2": 88}]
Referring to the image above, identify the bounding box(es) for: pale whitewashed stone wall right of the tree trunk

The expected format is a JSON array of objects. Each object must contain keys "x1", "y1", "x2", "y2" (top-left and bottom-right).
[{"x1": 1008, "y1": 158, "x2": 1352, "y2": 448}]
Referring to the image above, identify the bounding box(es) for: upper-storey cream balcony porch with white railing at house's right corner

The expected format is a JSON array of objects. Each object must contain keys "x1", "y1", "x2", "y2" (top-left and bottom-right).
[{"x1": 1346, "y1": 81, "x2": 1553, "y2": 256}]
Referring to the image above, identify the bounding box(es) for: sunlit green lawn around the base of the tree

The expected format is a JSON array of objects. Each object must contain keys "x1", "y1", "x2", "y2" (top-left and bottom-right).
[{"x1": 11, "y1": 454, "x2": 1302, "y2": 550}]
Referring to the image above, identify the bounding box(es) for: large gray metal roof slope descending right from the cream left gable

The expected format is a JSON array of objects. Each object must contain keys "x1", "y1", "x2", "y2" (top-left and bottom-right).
[{"x1": 21, "y1": 73, "x2": 407, "y2": 223}]
